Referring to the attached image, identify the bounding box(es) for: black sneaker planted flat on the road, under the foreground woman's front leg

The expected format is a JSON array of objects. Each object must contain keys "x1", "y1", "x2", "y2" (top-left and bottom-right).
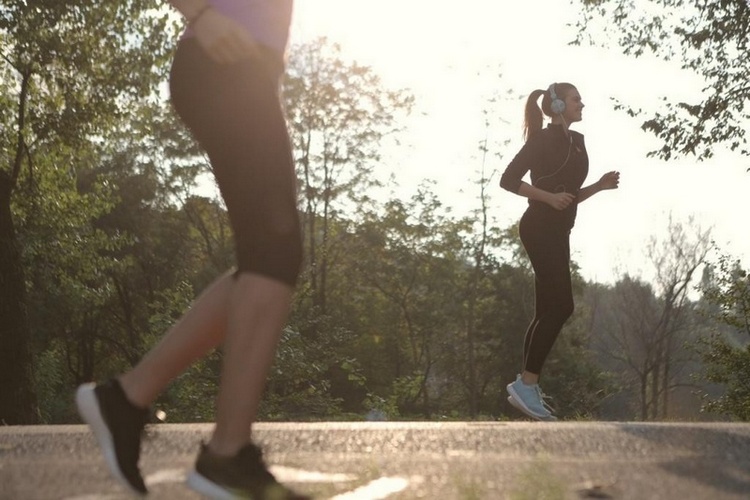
[{"x1": 187, "y1": 443, "x2": 311, "y2": 500}]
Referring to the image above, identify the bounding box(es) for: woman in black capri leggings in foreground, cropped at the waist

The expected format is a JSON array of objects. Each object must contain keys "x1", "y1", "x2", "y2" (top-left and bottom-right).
[{"x1": 76, "y1": 0, "x2": 307, "y2": 499}]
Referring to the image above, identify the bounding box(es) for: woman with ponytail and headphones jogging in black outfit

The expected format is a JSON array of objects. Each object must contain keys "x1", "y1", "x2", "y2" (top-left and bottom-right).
[{"x1": 500, "y1": 83, "x2": 620, "y2": 421}]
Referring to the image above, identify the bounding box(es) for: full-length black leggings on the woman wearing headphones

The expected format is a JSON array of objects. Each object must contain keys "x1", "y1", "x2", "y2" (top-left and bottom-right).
[{"x1": 519, "y1": 210, "x2": 574, "y2": 374}]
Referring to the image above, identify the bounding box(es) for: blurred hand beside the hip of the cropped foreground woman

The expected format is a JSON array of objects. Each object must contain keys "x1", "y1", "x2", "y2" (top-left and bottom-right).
[{"x1": 192, "y1": 7, "x2": 258, "y2": 64}]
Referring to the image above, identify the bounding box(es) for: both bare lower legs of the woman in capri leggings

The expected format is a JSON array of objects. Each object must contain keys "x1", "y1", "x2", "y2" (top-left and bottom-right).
[{"x1": 120, "y1": 273, "x2": 293, "y2": 455}]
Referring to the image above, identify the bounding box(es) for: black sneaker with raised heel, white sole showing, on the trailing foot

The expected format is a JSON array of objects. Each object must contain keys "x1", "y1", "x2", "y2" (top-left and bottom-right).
[{"x1": 76, "y1": 379, "x2": 149, "y2": 495}]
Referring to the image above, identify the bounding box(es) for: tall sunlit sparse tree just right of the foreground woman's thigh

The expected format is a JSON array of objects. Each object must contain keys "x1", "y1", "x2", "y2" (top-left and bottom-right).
[{"x1": 284, "y1": 39, "x2": 412, "y2": 320}]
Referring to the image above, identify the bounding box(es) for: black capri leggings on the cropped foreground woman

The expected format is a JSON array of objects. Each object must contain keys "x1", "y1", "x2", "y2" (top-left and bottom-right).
[{"x1": 169, "y1": 38, "x2": 302, "y2": 286}]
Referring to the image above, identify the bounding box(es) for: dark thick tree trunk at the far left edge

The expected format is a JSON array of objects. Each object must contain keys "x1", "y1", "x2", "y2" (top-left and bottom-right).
[{"x1": 0, "y1": 170, "x2": 38, "y2": 425}]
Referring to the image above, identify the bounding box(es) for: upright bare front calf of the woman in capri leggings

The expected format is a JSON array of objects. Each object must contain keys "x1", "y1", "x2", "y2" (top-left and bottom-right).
[{"x1": 209, "y1": 274, "x2": 293, "y2": 456}]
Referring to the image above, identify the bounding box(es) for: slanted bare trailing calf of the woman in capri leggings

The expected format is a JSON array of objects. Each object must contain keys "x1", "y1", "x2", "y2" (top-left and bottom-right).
[{"x1": 120, "y1": 274, "x2": 234, "y2": 408}]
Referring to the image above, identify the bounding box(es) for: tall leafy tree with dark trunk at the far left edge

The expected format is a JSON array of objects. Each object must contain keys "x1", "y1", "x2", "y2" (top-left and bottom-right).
[{"x1": 0, "y1": 0, "x2": 174, "y2": 423}]
